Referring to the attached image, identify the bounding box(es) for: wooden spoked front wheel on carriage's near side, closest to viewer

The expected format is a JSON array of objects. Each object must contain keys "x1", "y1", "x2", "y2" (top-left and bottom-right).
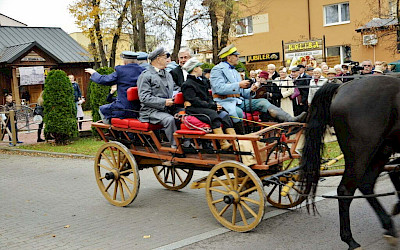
[{"x1": 206, "y1": 161, "x2": 265, "y2": 232}]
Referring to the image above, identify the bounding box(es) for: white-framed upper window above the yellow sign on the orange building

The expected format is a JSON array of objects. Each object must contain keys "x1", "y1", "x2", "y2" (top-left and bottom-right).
[{"x1": 324, "y1": 3, "x2": 350, "y2": 25}]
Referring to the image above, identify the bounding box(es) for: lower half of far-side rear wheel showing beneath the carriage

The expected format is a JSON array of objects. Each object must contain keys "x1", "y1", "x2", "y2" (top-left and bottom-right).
[{"x1": 153, "y1": 166, "x2": 194, "y2": 190}]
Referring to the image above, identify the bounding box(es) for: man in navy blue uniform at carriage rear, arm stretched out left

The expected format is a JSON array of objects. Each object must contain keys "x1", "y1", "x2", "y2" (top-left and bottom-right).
[{"x1": 85, "y1": 51, "x2": 144, "y2": 124}]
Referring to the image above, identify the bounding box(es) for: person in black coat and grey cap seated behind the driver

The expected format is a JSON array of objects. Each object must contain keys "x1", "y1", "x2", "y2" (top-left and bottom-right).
[{"x1": 182, "y1": 58, "x2": 236, "y2": 150}]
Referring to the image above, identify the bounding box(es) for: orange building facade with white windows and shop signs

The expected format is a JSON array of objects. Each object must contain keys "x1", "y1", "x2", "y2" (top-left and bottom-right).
[{"x1": 230, "y1": 0, "x2": 400, "y2": 70}]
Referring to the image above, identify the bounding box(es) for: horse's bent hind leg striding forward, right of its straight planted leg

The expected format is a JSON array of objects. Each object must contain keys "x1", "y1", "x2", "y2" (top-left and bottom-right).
[{"x1": 358, "y1": 157, "x2": 397, "y2": 244}]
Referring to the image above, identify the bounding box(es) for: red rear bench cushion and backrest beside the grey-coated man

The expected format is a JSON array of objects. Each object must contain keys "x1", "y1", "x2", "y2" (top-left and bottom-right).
[{"x1": 111, "y1": 87, "x2": 162, "y2": 131}]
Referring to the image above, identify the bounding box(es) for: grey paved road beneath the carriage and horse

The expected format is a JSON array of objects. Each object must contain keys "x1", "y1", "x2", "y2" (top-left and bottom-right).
[{"x1": 0, "y1": 154, "x2": 400, "y2": 249}]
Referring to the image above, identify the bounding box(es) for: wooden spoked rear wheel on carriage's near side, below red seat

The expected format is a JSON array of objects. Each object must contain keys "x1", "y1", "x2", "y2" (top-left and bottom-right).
[{"x1": 94, "y1": 141, "x2": 140, "y2": 207}]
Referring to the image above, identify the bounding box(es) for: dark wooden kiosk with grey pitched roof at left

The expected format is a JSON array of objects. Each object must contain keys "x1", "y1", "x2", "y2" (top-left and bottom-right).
[{"x1": 0, "y1": 26, "x2": 92, "y2": 105}]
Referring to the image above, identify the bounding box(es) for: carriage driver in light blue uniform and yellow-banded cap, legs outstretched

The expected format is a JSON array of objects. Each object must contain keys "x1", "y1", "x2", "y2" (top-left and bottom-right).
[{"x1": 210, "y1": 44, "x2": 306, "y2": 133}]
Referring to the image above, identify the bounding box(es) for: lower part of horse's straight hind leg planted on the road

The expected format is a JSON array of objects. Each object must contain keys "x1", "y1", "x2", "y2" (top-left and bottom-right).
[{"x1": 337, "y1": 174, "x2": 361, "y2": 249}]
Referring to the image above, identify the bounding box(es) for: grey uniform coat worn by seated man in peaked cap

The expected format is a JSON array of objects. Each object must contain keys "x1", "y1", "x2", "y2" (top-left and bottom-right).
[{"x1": 137, "y1": 65, "x2": 174, "y2": 124}]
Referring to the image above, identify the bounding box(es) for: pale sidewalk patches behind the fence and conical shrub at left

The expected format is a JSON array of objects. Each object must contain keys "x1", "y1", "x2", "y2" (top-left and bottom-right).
[{"x1": 0, "y1": 116, "x2": 92, "y2": 147}]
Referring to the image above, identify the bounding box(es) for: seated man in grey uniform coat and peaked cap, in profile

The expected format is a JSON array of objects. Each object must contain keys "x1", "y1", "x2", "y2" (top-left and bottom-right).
[{"x1": 138, "y1": 47, "x2": 177, "y2": 148}]
